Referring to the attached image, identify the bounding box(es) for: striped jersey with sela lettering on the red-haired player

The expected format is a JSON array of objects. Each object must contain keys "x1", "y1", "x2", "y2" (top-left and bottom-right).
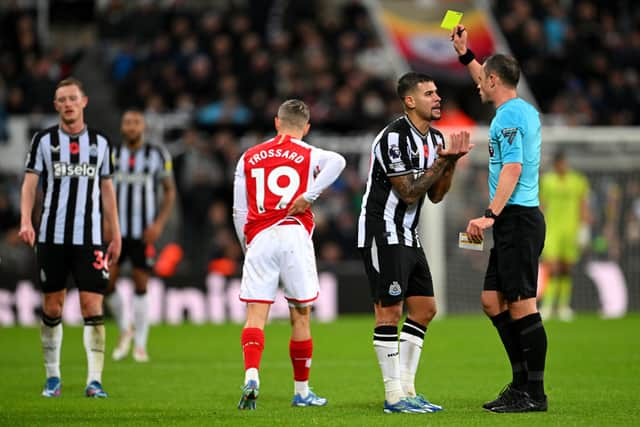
[{"x1": 26, "y1": 126, "x2": 113, "y2": 245}]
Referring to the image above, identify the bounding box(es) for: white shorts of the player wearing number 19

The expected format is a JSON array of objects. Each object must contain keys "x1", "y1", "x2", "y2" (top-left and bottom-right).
[{"x1": 240, "y1": 224, "x2": 320, "y2": 306}]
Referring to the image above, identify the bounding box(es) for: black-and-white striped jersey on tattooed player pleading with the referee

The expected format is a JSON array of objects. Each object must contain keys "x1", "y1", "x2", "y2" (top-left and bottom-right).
[{"x1": 358, "y1": 116, "x2": 444, "y2": 248}]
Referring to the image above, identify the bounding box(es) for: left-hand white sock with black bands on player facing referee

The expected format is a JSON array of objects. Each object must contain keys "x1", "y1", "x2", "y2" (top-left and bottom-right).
[{"x1": 373, "y1": 326, "x2": 404, "y2": 404}]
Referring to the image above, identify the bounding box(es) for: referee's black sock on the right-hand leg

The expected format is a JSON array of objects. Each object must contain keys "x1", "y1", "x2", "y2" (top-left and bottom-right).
[{"x1": 513, "y1": 313, "x2": 547, "y2": 400}]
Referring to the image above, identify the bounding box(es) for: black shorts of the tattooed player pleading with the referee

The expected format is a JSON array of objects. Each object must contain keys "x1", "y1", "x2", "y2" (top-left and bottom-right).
[{"x1": 360, "y1": 245, "x2": 433, "y2": 307}]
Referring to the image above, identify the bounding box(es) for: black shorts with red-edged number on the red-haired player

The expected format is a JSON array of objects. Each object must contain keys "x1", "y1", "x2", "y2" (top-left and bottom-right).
[{"x1": 36, "y1": 243, "x2": 109, "y2": 294}]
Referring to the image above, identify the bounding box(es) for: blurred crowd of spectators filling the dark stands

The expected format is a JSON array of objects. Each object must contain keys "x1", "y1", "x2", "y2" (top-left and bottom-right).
[{"x1": 0, "y1": 0, "x2": 640, "y2": 284}]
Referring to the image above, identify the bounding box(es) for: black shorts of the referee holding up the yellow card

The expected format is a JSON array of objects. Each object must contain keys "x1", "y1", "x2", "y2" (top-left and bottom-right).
[{"x1": 484, "y1": 205, "x2": 546, "y2": 302}]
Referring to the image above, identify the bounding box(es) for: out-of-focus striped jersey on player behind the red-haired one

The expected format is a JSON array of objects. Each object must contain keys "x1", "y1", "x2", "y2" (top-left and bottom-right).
[{"x1": 113, "y1": 142, "x2": 172, "y2": 239}]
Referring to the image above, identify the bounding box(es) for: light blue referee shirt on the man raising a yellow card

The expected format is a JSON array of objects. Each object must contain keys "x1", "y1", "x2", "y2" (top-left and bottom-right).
[{"x1": 489, "y1": 98, "x2": 542, "y2": 207}]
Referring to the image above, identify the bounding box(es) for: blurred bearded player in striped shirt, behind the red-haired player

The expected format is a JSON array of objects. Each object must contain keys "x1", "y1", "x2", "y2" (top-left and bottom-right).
[{"x1": 107, "y1": 110, "x2": 175, "y2": 362}]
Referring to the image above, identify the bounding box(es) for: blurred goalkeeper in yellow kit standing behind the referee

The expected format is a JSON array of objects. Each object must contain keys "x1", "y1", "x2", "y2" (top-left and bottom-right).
[{"x1": 540, "y1": 151, "x2": 590, "y2": 321}]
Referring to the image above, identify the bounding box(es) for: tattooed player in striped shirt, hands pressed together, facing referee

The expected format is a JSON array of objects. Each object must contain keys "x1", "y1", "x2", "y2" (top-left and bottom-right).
[{"x1": 358, "y1": 73, "x2": 471, "y2": 413}]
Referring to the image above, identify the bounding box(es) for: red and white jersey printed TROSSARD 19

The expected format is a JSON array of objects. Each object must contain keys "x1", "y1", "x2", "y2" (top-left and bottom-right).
[{"x1": 234, "y1": 135, "x2": 324, "y2": 245}]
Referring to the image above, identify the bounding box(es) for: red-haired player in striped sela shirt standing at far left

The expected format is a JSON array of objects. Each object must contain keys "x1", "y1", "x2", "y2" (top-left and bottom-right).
[{"x1": 20, "y1": 79, "x2": 121, "y2": 397}]
